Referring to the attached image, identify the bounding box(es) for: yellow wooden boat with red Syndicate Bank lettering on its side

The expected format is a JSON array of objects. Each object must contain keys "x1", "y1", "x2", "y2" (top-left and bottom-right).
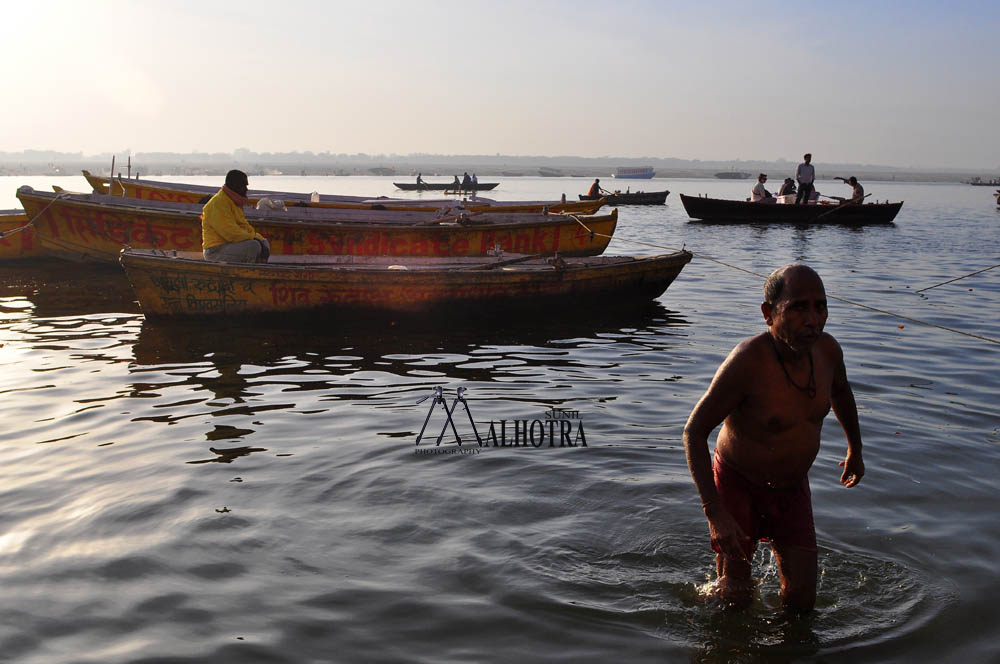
[{"x1": 17, "y1": 187, "x2": 618, "y2": 262}]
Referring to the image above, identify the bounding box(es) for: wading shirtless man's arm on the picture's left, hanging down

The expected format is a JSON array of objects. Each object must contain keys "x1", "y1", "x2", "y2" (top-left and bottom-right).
[{"x1": 684, "y1": 342, "x2": 747, "y2": 558}]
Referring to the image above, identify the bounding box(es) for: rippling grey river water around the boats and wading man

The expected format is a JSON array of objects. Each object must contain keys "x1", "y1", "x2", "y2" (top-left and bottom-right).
[{"x1": 0, "y1": 173, "x2": 1000, "y2": 664}]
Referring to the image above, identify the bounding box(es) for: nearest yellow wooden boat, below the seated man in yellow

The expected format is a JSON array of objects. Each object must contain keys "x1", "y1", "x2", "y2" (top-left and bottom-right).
[{"x1": 120, "y1": 249, "x2": 691, "y2": 317}]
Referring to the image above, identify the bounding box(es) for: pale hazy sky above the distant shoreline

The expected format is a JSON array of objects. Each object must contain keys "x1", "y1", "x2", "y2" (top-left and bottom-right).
[{"x1": 0, "y1": 0, "x2": 1000, "y2": 172}]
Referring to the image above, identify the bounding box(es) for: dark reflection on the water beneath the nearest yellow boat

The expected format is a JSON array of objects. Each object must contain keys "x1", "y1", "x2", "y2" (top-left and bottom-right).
[{"x1": 133, "y1": 300, "x2": 689, "y2": 374}]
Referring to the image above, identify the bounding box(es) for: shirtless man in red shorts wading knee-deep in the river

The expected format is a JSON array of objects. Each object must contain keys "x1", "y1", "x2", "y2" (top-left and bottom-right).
[{"x1": 684, "y1": 265, "x2": 865, "y2": 611}]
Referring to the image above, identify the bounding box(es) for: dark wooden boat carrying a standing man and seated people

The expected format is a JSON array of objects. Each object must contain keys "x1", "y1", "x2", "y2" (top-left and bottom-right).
[{"x1": 681, "y1": 194, "x2": 903, "y2": 225}]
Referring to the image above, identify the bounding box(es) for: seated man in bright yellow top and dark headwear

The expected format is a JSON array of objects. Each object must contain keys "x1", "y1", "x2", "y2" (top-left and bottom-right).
[{"x1": 201, "y1": 170, "x2": 271, "y2": 263}]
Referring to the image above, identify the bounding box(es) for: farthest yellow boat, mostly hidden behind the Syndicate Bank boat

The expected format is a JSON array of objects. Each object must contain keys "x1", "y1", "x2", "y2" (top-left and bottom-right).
[{"x1": 83, "y1": 170, "x2": 607, "y2": 214}]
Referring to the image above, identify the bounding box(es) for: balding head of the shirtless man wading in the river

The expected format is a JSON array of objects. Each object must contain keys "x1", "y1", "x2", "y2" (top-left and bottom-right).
[{"x1": 760, "y1": 263, "x2": 827, "y2": 351}]
